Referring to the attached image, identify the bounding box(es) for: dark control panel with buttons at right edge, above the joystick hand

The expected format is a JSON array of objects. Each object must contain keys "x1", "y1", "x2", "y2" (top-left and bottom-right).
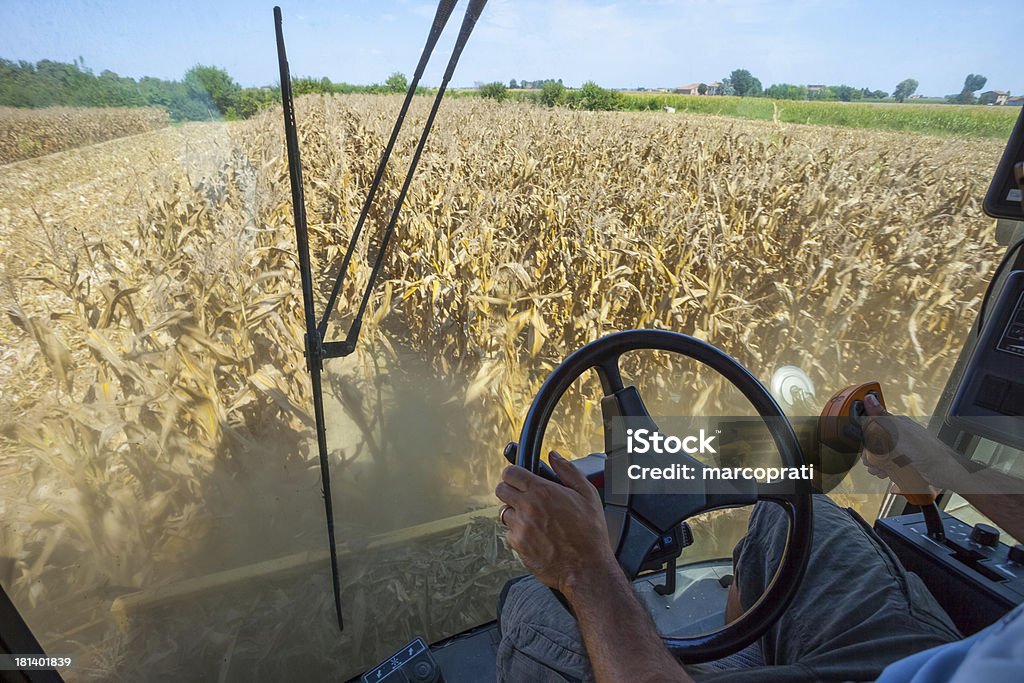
[{"x1": 947, "y1": 270, "x2": 1024, "y2": 449}]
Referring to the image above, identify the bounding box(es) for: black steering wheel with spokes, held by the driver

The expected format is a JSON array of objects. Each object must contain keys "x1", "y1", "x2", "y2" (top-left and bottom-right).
[{"x1": 516, "y1": 330, "x2": 813, "y2": 663}]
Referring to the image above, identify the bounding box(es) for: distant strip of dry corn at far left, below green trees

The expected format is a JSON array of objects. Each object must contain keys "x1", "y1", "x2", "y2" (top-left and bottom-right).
[{"x1": 0, "y1": 106, "x2": 170, "y2": 164}]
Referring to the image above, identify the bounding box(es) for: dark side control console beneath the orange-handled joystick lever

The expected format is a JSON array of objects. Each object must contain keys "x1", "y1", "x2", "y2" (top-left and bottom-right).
[{"x1": 874, "y1": 512, "x2": 1024, "y2": 635}]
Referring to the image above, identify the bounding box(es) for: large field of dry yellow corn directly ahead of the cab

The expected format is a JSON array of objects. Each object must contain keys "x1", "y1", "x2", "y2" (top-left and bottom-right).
[{"x1": 0, "y1": 95, "x2": 1001, "y2": 680}]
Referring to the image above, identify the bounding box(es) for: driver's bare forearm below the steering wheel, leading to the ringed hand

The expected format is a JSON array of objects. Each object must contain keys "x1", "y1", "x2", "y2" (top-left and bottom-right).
[{"x1": 565, "y1": 560, "x2": 692, "y2": 683}]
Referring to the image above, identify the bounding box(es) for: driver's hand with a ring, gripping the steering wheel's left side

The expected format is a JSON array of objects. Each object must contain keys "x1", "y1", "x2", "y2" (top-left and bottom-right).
[{"x1": 495, "y1": 452, "x2": 617, "y2": 597}]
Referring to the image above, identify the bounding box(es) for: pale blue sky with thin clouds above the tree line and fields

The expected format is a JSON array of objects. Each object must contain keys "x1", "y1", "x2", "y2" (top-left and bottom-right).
[{"x1": 8, "y1": 0, "x2": 1024, "y2": 95}]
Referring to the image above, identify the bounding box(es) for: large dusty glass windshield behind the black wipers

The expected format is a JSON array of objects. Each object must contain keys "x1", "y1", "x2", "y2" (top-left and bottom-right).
[{"x1": 0, "y1": 0, "x2": 1024, "y2": 680}]
